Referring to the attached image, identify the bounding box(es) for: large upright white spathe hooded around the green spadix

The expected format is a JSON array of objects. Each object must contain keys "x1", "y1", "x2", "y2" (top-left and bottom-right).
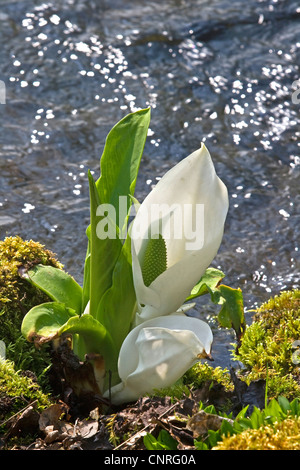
[{"x1": 131, "y1": 144, "x2": 228, "y2": 324}]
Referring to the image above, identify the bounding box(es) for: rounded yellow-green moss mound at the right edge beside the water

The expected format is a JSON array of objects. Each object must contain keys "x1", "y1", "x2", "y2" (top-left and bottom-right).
[{"x1": 234, "y1": 290, "x2": 300, "y2": 398}]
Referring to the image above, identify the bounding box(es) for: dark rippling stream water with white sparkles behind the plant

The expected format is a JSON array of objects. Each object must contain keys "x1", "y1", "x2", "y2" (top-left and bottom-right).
[{"x1": 0, "y1": 0, "x2": 300, "y2": 364}]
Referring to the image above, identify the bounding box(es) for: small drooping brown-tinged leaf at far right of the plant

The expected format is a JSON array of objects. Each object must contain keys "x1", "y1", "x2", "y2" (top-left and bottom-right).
[{"x1": 218, "y1": 285, "x2": 245, "y2": 340}]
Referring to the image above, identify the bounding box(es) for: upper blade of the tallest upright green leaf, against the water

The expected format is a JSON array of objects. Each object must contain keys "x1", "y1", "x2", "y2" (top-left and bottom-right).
[{"x1": 96, "y1": 108, "x2": 151, "y2": 229}]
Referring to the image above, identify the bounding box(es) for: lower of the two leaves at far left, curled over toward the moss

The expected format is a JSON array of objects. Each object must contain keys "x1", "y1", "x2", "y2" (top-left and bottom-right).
[{"x1": 21, "y1": 302, "x2": 77, "y2": 343}]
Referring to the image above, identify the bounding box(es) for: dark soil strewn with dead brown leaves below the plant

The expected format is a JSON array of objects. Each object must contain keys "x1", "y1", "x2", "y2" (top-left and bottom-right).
[{"x1": 0, "y1": 360, "x2": 265, "y2": 450}]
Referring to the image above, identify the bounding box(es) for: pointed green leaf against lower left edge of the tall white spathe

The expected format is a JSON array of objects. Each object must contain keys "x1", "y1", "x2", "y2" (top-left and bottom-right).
[{"x1": 97, "y1": 235, "x2": 136, "y2": 348}]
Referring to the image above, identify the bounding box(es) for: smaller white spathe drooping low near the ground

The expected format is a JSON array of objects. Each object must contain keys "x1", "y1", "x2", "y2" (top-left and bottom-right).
[{"x1": 104, "y1": 314, "x2": 213, "y2": 404}]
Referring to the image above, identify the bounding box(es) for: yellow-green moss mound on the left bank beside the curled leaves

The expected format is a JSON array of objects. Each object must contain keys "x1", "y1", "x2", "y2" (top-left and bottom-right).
[{"x1": 0, "y1": 237, "x2": 62, "y2": 375}]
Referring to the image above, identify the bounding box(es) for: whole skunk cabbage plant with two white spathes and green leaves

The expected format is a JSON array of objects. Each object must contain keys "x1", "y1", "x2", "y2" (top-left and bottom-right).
[{"x1": 22, "y1": 109, "x2": 244, "y2": 403}]
